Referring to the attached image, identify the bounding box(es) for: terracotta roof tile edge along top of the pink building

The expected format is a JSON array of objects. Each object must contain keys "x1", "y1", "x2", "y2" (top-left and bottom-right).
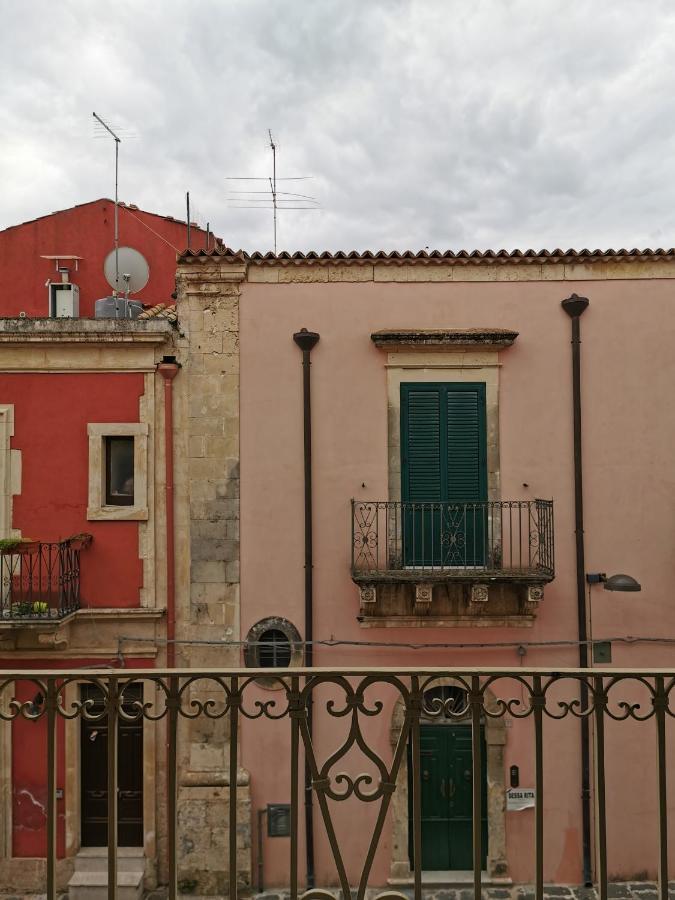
[{"x1": 180, "y1": 247, "x2": 675, "y2": 266}]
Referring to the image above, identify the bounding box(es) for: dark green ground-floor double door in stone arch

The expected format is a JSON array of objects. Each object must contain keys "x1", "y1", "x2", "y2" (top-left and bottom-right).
[{"x1": 408, "y1": 725, "x2": 487, "y2": 872}]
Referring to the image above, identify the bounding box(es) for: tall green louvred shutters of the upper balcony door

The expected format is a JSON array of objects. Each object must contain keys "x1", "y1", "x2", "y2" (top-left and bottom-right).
[{"x1": 401, "y1": 382, "x2": 487, "y2": 567}]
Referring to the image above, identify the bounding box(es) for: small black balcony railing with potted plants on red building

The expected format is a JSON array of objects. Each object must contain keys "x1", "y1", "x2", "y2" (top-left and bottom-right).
[{"x1": 0, "y1": 534, "x2": 92, "y2": 620}]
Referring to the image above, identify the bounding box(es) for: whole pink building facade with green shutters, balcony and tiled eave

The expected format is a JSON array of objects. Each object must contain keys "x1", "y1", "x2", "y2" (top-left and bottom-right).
[{"x1": 178, "y1": 251, "x2": 675, "y2": 886}]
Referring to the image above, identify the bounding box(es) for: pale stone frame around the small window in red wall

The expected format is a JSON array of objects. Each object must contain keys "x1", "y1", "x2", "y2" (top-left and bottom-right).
[{"x1": 87, "y1": 422, "x2": 149, "y2": 522}]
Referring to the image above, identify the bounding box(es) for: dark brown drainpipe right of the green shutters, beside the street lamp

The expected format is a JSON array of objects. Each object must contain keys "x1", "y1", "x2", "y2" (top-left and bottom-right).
[{"x1": 561, "y1": 294, "x2": 593, "y2": 887}]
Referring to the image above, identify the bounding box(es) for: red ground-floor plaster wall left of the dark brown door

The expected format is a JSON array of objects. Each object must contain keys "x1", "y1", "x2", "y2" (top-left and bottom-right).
[{"x1": 6, "y1": 659, "x2": 154, "y2": 858}]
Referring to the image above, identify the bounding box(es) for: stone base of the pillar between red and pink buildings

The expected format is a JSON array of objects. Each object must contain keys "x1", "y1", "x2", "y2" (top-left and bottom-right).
[{"x1": 178, "y1": 784, "x2": 251, "y2": 897}]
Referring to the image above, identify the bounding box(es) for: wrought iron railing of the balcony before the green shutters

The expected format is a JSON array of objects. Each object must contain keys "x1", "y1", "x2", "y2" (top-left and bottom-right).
[{"x1": 352, "y1": 500, "x2": 554, "y2": 581}]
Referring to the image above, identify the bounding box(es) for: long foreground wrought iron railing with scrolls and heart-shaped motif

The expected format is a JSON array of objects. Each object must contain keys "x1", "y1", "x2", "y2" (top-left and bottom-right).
[{"x1": 0, "y1": 668, "x2": 675, "y2": 900}]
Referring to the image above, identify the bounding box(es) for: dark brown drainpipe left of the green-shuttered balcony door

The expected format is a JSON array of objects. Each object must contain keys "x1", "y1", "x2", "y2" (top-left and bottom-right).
[{"x1": 293, "y1": 328, "x2": 319, "y2": 891}]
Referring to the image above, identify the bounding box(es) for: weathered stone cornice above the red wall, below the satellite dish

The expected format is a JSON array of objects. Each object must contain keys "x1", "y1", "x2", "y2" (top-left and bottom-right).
[{"x1": 0, "y1": 318, "x2": 174, "y2": 345}]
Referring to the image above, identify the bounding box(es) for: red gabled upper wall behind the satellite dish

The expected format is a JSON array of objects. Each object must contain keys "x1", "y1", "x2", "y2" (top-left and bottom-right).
[{"x1": 0, "y1": 200, "x2": 214, "y2": 316}]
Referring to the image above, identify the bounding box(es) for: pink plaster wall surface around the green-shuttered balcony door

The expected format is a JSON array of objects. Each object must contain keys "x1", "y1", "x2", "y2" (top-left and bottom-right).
[{"x1": 236, "y1": 280, "x2": 675, "y2": 885}]
